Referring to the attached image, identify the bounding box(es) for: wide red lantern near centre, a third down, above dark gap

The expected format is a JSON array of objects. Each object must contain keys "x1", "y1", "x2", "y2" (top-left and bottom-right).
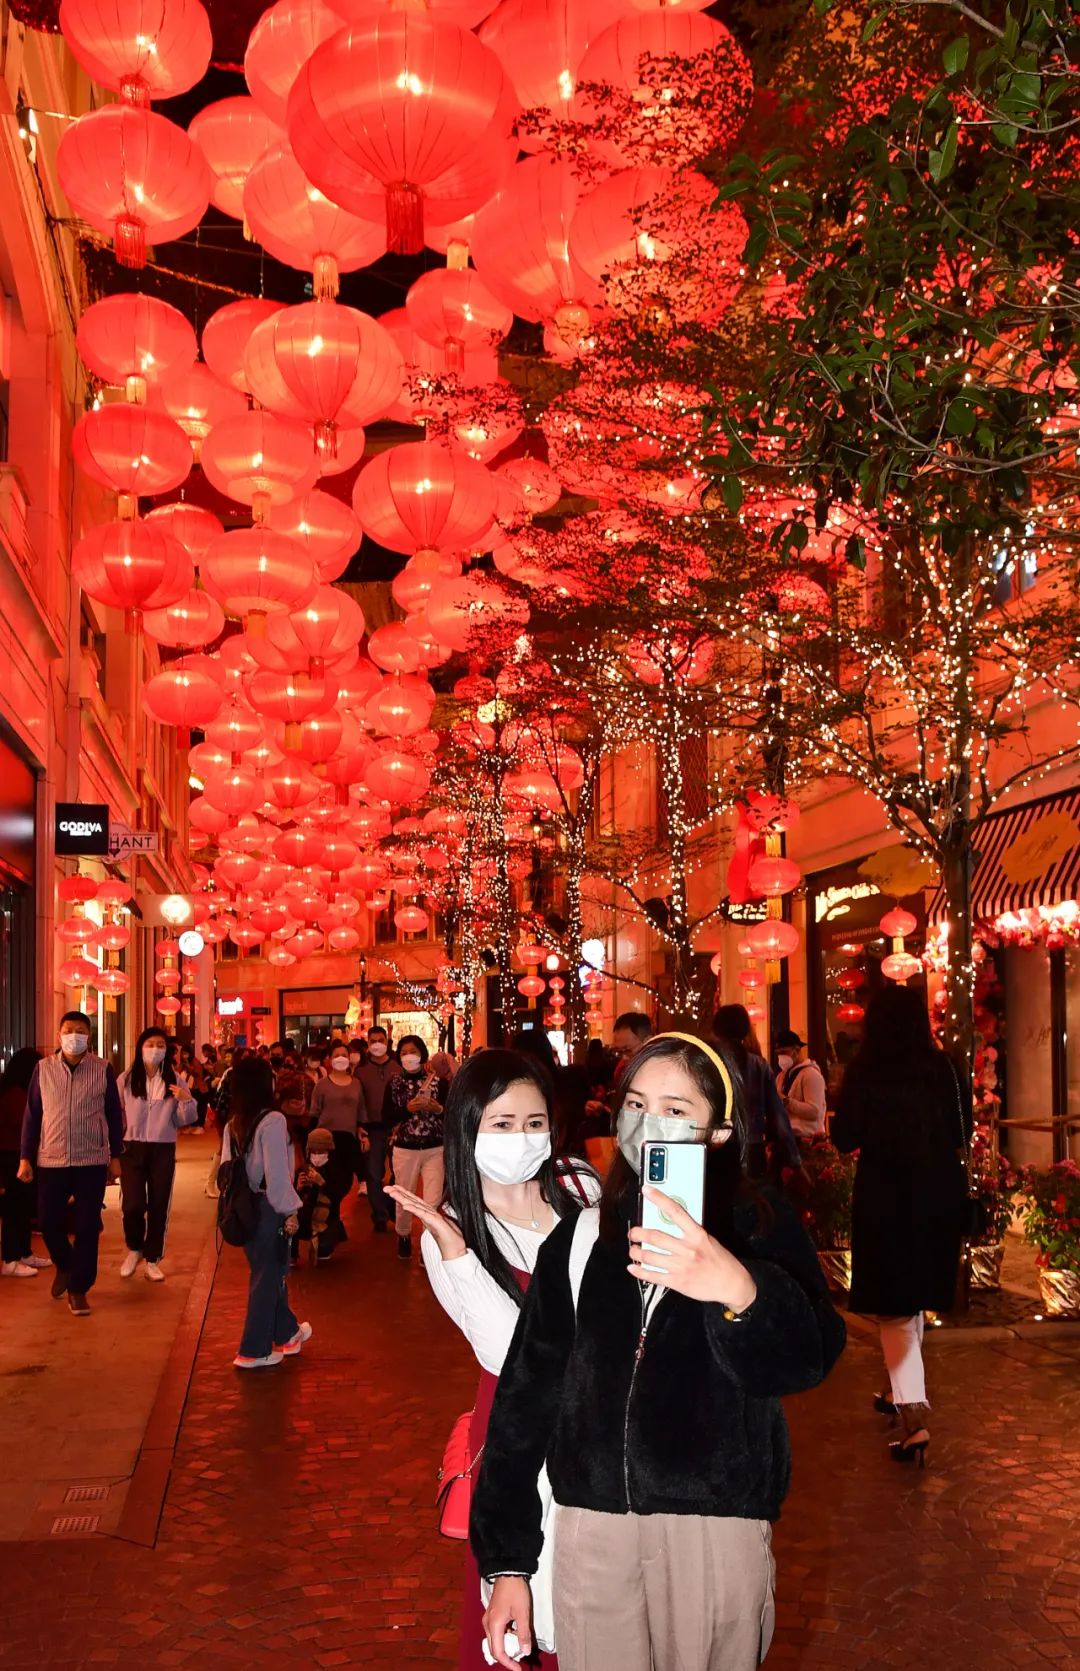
[{"x1": 353, "y1": 441, "x2": 495, "y2": 551}]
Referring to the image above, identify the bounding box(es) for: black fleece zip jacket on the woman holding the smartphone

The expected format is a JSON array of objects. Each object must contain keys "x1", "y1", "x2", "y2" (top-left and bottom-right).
[{"x1": 470, "y1": 1200, "x2": 844, "y2": 1574}]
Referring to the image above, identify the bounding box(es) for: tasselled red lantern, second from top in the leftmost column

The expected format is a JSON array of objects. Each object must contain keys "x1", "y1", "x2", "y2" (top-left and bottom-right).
[{"x1": 57, "y1": 105, "x2": 211, "y2": 267}]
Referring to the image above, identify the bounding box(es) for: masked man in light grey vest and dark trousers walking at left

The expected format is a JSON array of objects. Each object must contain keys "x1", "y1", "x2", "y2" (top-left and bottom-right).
[{"x1": 18, "y1": 1009, "x2": 124, "y2": 1317}]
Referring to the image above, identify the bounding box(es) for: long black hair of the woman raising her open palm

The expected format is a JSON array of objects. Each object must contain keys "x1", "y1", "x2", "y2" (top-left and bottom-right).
[{"x1": 441, "y1": 1049, "x2": 582, "y2": 1305}]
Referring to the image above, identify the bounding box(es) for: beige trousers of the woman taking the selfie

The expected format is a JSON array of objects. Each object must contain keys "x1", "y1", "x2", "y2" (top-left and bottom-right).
[{"x1": 555, "y1": 1507, "x2": 776, "y2": 1671}]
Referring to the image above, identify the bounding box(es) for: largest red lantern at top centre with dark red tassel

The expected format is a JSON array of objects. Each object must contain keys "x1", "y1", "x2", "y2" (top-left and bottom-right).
[{"x1": 289, "y1": 12, "x2": 510, "y2": 254}]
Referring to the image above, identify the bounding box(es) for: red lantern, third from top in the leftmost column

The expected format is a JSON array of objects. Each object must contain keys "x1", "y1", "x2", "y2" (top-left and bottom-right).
[{"x1": 75, "y1": 292, "x2": 196, "y2": 403}]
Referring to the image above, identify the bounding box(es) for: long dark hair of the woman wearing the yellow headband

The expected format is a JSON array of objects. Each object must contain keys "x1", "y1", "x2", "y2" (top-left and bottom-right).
[{"x1": 600, "y1": 1033, "x2": 747, "y2": 1247}]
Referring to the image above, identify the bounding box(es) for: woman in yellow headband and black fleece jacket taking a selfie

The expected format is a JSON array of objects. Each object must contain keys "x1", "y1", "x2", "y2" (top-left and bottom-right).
[{"x1": 471, "y1": 1033, "x2": 844, "y2": 1671}]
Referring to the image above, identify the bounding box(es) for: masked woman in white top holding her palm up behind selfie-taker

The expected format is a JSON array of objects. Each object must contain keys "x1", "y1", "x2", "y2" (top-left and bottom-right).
[{"x1": 386, "y1": 1049, "x2": 600, "y2": 1671}]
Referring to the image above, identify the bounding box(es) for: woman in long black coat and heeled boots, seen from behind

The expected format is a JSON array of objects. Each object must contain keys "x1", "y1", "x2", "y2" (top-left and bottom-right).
[{"x1": 831, "y1": 986, "x2": 971, "y2": 1465}]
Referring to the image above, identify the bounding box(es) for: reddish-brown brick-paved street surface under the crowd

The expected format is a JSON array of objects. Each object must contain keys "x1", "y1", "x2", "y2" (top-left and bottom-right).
[{"x1": 0, "y1": 1158, "x2": 1080, "y2": 1671}]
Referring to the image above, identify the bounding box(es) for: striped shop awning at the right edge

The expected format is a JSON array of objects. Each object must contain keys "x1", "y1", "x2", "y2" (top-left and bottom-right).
[{"x1": 928, "y1": 789, "x2": 1080, "y2": 922}]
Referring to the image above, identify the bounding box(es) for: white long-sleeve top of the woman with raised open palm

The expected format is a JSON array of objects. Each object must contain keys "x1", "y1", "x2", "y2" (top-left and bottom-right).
[{"x1": 420, "y1": 1171, "x2": 600, "y2": 1375}]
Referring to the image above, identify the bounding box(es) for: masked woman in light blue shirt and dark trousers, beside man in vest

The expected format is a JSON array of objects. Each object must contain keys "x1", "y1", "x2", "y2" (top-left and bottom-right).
[{"x1": 119, "y1": 1028, "x2": 197, "y2": 1282}]
